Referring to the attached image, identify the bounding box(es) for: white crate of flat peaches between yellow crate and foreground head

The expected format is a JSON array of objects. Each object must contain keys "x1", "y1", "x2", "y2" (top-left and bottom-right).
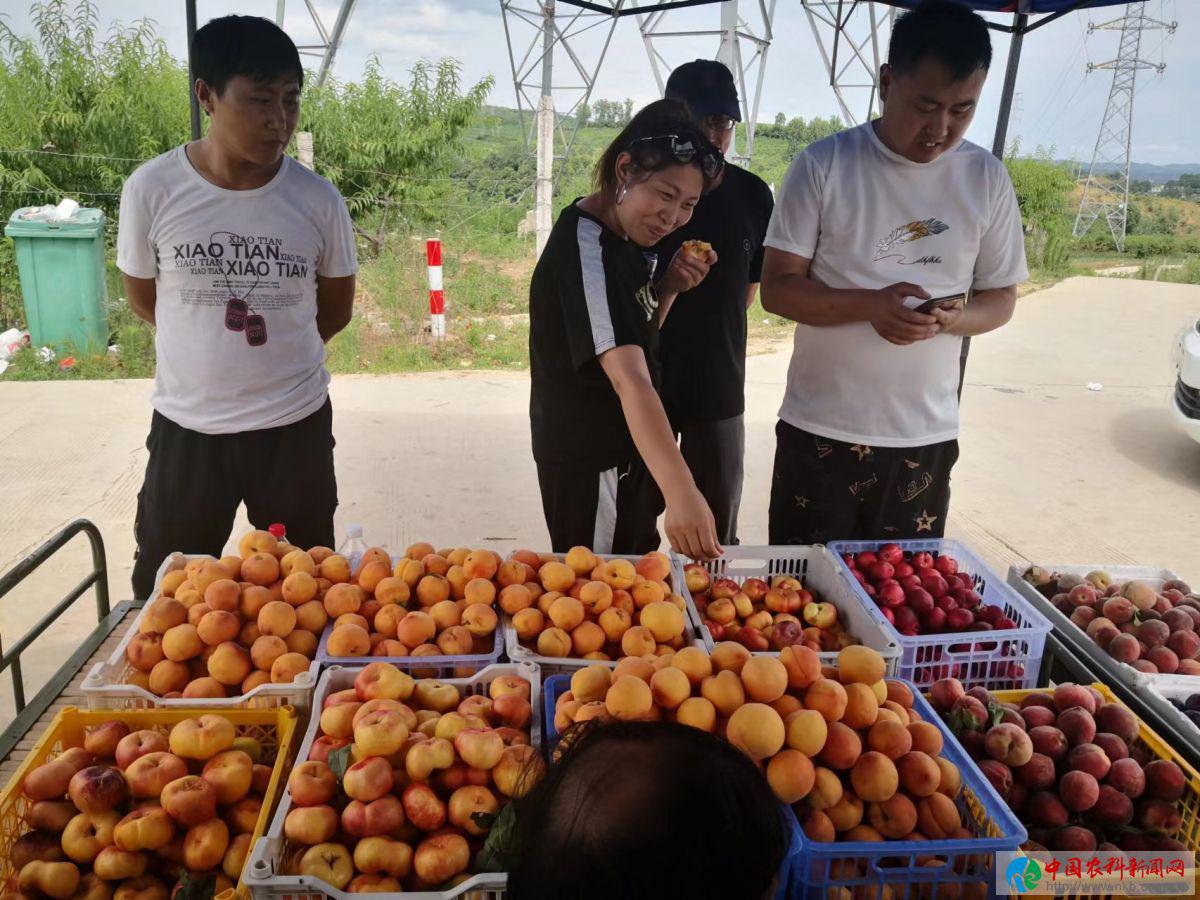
[{"x1": 242, "y1": 662, "x2": 541, "y2": 900}]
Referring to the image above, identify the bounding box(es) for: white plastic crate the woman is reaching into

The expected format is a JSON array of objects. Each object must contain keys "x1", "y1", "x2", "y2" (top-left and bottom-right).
[{"x1": 673, "y1": 544, "x2": 900, "y2": 674}]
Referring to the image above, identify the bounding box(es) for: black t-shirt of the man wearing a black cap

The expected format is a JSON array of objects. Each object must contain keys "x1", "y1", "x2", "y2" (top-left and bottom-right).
[{"x1": 654, "y1": 164, "x2": 775, "y2": 425}]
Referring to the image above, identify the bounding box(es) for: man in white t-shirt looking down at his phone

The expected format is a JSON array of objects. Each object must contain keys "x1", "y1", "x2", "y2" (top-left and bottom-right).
[{"x1": 762, "y1": 0, "x2": 1028, "y2": 545}]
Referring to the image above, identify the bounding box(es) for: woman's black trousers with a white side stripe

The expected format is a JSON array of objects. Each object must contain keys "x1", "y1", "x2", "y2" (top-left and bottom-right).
[{"x1": 538, "y1": 460, "x2": 662, "y2": 554}]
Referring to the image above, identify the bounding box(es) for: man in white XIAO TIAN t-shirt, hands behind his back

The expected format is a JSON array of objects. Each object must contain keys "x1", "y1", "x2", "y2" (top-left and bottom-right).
[{"x1": 116, "y1": 16, "x2": 358, "y2": 600}]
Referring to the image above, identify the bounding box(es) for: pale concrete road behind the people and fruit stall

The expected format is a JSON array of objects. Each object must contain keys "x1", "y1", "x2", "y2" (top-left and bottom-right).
[{"x1": 0, "y1": 278, "x2": 1200, "y2": 719}]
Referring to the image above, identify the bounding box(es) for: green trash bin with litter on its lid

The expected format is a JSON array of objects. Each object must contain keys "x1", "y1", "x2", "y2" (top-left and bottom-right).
[{"x1": 4, "y1": 208, "x2": 108, "y2": 353}]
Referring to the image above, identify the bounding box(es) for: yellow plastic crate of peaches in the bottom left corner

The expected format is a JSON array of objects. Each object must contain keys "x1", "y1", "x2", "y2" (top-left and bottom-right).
[{"x1": 0, "y1": 707, "x2": 298, "y2": 898}]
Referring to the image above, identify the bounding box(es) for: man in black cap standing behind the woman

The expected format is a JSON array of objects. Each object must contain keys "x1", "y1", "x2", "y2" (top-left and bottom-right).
[{"x1": 655, "y1": 59, "x2": 774, "y2": 545}]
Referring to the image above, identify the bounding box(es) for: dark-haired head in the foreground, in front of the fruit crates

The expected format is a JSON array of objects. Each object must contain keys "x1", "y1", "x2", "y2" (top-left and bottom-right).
[{"x1": 509, "y1": 719, "x2": 791, "y2": 900}]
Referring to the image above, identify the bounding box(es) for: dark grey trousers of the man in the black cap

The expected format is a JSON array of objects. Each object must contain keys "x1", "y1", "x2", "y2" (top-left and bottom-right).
[{"x1": 672, "y1": 415, "x2": 746, "y2": 546}]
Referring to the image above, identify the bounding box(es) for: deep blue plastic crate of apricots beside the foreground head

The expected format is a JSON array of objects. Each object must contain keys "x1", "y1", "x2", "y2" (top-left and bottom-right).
[{"x1": 541, "y1": 676, "x2": 1028, "y2": 900}]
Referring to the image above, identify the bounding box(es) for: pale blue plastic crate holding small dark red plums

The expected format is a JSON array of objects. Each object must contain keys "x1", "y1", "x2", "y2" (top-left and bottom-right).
[{"x1": 829, "y1": 539, "x2": 1050, "y2": 690}]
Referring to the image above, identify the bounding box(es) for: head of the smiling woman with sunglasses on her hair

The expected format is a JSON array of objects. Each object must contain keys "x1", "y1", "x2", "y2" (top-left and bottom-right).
[{"x1": 589, "y1": 100, "x2": 725, "y2": 247}]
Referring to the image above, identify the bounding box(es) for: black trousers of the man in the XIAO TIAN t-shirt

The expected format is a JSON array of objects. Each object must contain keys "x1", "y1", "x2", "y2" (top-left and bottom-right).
[{"x1": 133, "y1": 397, "x2": 337, "y2": 600}]
